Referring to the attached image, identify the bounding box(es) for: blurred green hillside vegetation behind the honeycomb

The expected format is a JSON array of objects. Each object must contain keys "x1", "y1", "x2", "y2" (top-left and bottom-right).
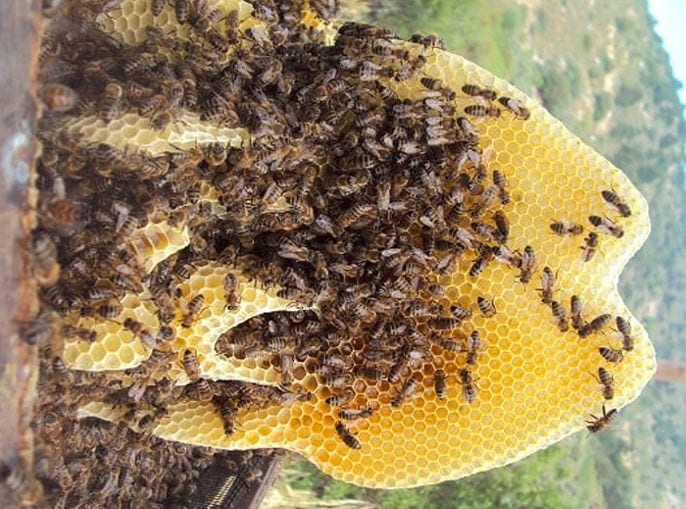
[{"x1": 268, "y1": 0, "x2": 686, "y2": 509}]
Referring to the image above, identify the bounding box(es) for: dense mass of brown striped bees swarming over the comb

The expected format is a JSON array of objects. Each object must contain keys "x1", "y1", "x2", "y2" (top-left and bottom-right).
[{"x1": 25, "y1": 0, "x2": 656, "y2": 496}]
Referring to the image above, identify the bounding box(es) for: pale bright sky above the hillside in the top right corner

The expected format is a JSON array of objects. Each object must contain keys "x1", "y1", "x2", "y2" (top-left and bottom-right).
[{"x1": 648, "y1": 0, "x2": 686, "y2": 104}]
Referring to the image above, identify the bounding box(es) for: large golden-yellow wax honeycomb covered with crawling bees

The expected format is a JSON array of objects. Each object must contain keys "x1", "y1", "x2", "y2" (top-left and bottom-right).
[{"x1": 36, "y1": 0, "x2": 655, "y2": 488}]
